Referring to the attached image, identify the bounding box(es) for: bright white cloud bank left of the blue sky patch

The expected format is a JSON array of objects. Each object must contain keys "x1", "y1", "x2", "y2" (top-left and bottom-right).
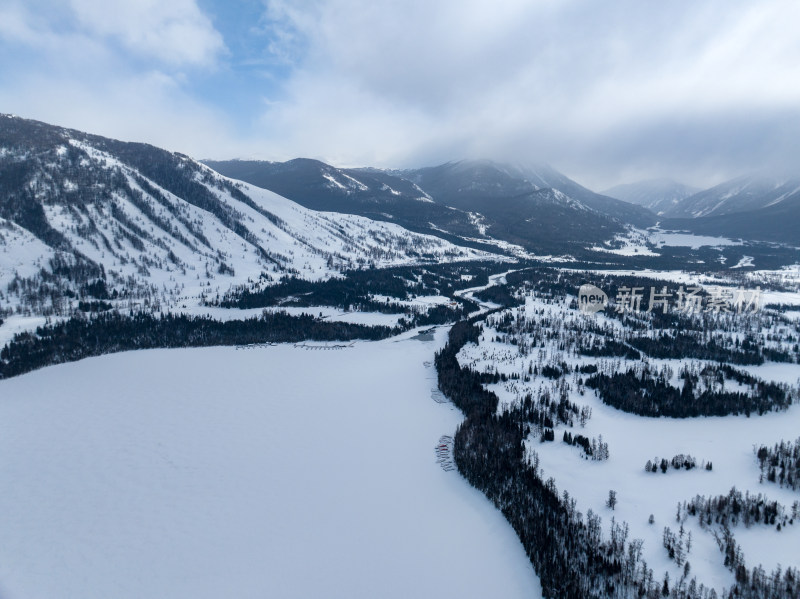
[{"x1": 0, "y1": 0, "x2": 239, "y2": 156}]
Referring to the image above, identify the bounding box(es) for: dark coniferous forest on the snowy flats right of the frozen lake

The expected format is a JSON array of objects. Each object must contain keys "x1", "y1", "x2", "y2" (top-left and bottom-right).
[{"x1": 435, "y1": 272, "x2": 800, "y2": 599}]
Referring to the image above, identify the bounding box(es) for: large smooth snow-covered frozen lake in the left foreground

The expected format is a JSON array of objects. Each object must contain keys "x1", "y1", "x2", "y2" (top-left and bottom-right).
[{"x1": 0, "y1": 329, "x2": 544, "y2": 599}]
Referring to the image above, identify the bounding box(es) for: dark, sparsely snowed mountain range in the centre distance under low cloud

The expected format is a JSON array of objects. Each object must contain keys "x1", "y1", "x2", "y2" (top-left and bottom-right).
[{"x1": 205, "y1": 159, "x2": 656, "y2": 253}]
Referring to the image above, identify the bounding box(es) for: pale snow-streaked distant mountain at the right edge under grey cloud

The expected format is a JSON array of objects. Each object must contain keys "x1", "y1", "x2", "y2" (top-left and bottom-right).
[{"x1": 664, "y1": 176, "x2": 800, "y2": 218}]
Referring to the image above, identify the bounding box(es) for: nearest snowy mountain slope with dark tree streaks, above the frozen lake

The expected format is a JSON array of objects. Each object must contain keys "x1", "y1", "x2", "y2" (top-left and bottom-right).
[{"x1": 0, "y1": 116, "x2": 486, "y2": 314}]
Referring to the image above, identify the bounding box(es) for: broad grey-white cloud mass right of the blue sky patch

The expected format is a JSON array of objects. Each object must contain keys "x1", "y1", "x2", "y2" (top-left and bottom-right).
[{"x1": 253, "y1": 0, "x2": 800, "y2": 184}]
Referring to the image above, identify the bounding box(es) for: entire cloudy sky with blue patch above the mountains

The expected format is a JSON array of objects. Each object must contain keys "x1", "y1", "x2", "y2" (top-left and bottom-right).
[{"x1": 0, "y1": 0, "x2": 800, "y2": 189}]
